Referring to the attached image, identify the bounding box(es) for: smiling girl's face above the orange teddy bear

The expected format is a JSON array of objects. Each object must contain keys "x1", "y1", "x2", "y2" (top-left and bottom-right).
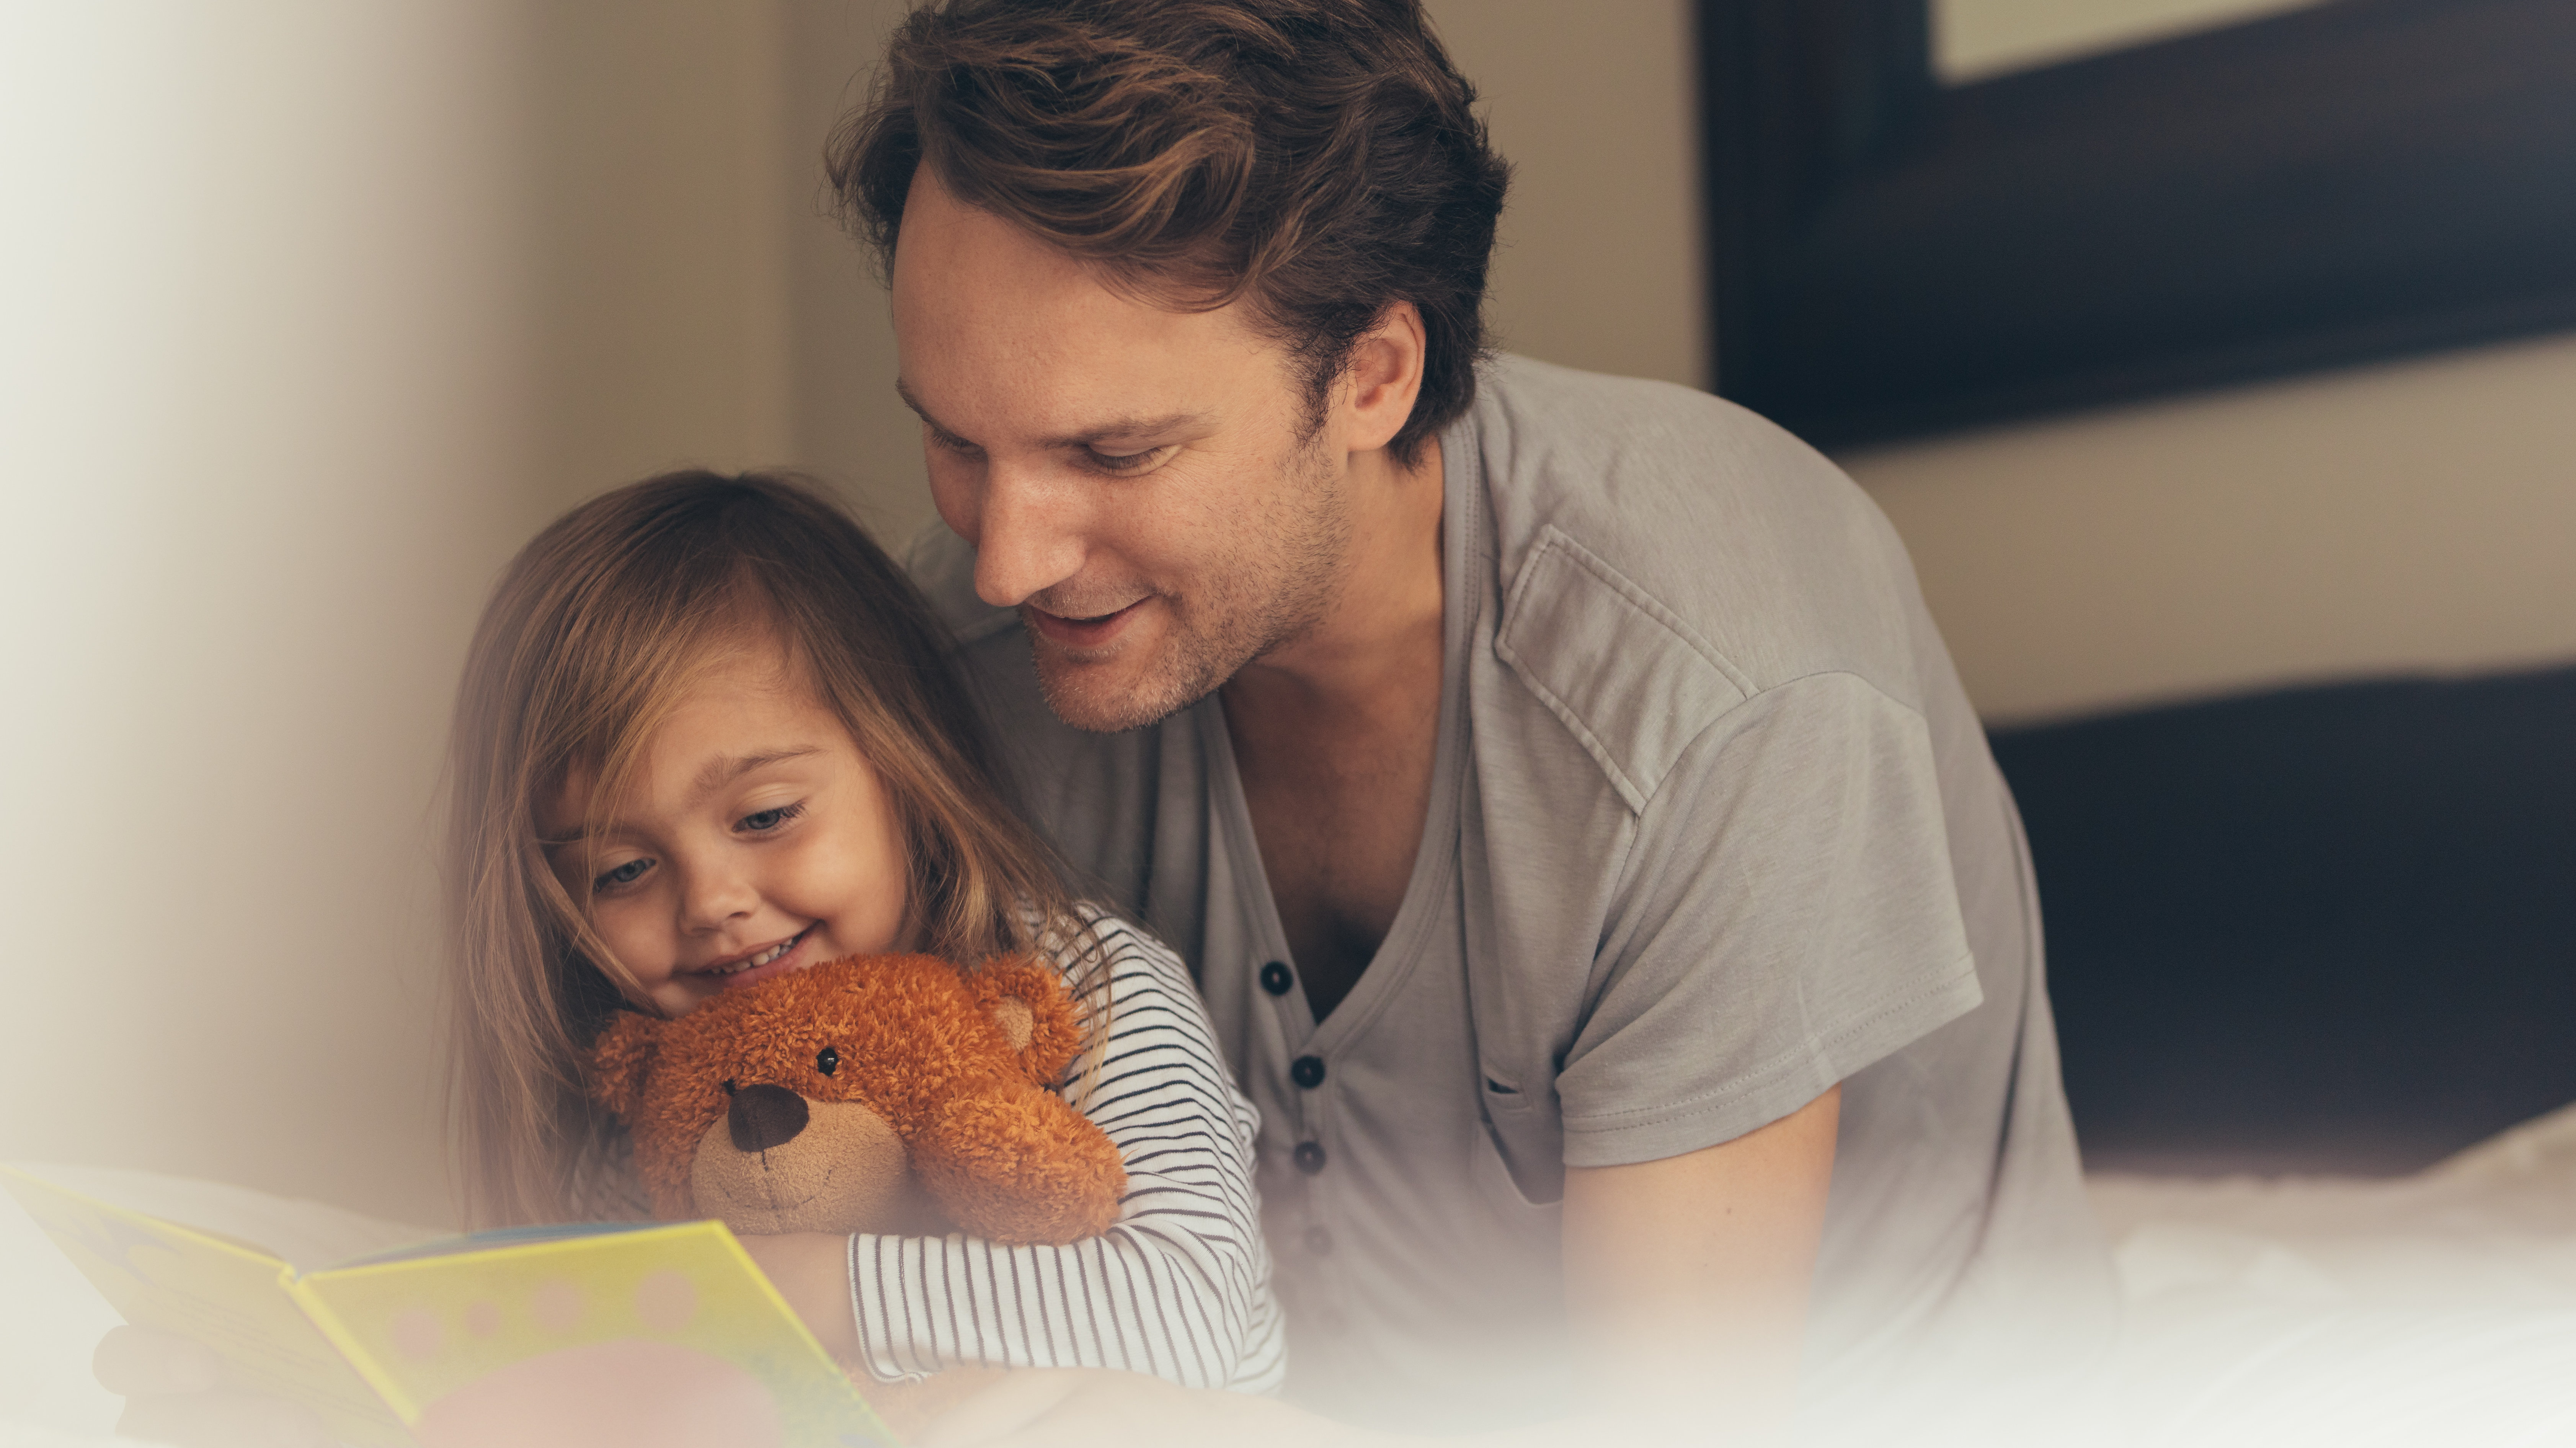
[{"x1": 539, "y1": 644, "x2": 917, "y2": 1015}]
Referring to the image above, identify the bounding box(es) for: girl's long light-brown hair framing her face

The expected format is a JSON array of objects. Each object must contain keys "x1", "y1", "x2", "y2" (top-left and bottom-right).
[{"x1": 448, "y1": 472, "x2": 1097, "y2": 1224}]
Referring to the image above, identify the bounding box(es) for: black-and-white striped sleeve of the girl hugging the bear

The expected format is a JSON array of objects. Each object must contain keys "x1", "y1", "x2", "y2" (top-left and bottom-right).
[{"x1": 850, "y1": 915, "x2": 1288, "y2": 1391}]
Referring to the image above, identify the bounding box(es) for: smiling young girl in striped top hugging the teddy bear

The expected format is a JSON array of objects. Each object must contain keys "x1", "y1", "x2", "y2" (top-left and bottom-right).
[{"x1": 451, "y1": 472, "x2": 1283, "y2": 1389}]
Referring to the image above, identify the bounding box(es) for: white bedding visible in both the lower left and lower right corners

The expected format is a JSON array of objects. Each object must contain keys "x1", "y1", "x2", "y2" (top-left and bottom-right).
[{"x1": 0, "y1": 1108, "x2": 2576, "y2": 1448}]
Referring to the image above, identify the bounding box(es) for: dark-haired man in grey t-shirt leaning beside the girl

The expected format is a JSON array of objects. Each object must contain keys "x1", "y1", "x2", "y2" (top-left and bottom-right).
[{"x1": 832, "y1": 0, "x2": 2107, "y2": 1438}]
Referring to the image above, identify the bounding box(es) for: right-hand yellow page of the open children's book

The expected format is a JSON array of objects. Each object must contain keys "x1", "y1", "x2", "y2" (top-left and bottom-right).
[{"x1": 296, "y1": 1221, "x2": 894, "y2": 1448}]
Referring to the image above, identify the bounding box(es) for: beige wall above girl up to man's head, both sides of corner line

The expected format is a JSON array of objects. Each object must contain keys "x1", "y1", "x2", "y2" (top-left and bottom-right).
[{"x1": 513, "y1": 0, "x2": 930, "y2": 541}]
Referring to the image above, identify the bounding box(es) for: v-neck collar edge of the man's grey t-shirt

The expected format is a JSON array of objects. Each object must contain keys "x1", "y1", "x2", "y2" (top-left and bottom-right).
[{"x1": 1198, "y1": 420, "x2": 1486, "y2": 1054}]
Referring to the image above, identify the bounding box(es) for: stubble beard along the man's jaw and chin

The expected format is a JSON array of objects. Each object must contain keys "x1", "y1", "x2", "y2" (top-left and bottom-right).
[{"x1": 1035, "y1": 428, "x2": 1352, "y2": 734}]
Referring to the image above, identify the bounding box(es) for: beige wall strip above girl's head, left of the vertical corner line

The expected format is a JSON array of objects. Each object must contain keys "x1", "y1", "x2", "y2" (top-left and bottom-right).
[{"x1": 518, "y1": 0, "x2": 793, "y2": 500}]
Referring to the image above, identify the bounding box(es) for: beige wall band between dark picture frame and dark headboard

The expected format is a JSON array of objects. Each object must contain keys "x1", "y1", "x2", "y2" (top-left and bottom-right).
[{"x1": 1845, "y1": 338, "x2": 2576, "y2": 722}]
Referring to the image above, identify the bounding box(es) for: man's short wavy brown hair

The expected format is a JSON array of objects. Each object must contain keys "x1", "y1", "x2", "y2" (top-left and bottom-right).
[{"x1": 827, "y1": 0, "x2": 1510, "y2": 466}]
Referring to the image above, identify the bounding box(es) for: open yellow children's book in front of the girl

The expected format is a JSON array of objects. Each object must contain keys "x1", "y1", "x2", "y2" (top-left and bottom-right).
[{"x1": 0, "y1": 1167, "x2": 894, "y2": 1448}]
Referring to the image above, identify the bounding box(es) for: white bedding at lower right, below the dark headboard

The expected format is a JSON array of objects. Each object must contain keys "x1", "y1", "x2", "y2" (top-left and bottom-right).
[{"x1": 2074, "y1": 1108, "x2": 2576, "y2": 1448}]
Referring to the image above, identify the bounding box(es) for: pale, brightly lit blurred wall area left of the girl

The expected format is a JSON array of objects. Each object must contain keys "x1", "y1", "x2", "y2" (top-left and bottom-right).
[{"x1": 0, "y1": 0, "x2": 541, "y2": 1216}]
